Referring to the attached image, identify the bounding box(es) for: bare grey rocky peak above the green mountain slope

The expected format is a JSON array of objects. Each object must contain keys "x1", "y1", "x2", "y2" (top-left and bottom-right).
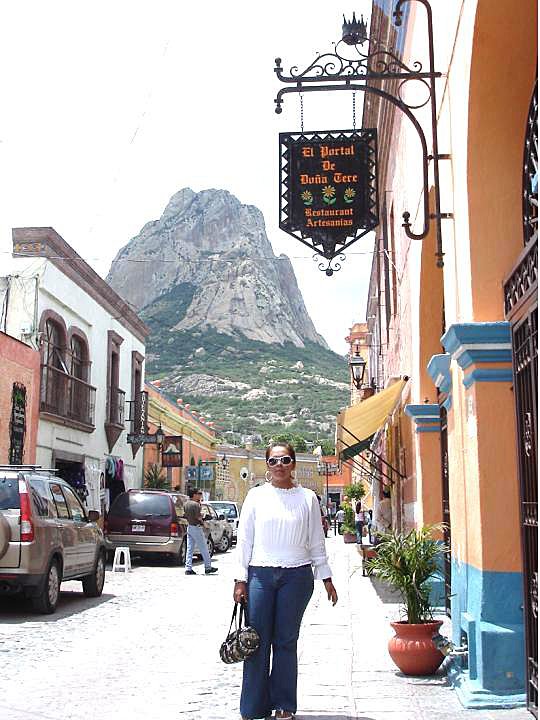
[{"x1": 107, "y1": 188, "x2": 326, "y2": 347}]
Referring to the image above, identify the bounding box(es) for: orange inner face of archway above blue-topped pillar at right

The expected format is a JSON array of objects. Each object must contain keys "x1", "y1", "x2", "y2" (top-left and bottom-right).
[{"x1": 467, "y1": 0, "x2": 538, "y2": 322}]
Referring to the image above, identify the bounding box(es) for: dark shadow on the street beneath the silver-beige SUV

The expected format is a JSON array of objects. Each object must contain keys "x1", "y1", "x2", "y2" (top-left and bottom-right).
[{"x1": 0, "y1": 590, "x2": 116, "y2": 625}]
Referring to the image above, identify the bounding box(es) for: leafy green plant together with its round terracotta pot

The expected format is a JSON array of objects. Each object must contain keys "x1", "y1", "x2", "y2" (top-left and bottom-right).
[{"x1": 367, "y1": 526, "x2": 448, "y2": 675}]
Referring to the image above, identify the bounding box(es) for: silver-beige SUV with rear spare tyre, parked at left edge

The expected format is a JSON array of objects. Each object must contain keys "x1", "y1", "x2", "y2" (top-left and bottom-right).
[{"x1": 0, "y1": 465, "x2": 105, "y2": 613}]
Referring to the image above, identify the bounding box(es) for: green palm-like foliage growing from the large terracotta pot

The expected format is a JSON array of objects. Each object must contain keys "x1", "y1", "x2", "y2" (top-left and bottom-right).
[{"x1": 367, "y1": 525, "x2": 448, "y2": 625}]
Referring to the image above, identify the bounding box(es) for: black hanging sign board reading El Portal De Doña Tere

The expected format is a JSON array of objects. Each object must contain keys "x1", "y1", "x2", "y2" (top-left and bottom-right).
[{"x1": 279, "y1": 129, "x2": 379, "y2": 275}]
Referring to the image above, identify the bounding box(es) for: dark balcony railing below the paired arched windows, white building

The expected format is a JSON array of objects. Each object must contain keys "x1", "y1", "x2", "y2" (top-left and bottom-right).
[{"x1": 40, "y1": 365, "x2": 96, "y2": 427}]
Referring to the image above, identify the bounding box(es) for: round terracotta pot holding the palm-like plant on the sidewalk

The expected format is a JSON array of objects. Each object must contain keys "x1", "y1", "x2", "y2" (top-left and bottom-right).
[{"x1": 388, "y1": 620, "x2": 444, "y2": 675}]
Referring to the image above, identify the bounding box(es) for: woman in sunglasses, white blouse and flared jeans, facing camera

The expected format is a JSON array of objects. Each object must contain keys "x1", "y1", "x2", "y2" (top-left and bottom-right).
[{"x1": 234, "y1": 443, "x2": 337, "y2": 720}]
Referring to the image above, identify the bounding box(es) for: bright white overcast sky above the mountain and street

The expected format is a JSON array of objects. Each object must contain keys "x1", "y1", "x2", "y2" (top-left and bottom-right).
[{"x1": 0, "y1": 0, "x2": 373, "y2": 354}]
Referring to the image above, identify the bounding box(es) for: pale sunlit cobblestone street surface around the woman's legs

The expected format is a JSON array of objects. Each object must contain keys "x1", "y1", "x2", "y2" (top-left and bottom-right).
[{"x1": 0, "y1": 538, "x2": 531, "y2": 720}]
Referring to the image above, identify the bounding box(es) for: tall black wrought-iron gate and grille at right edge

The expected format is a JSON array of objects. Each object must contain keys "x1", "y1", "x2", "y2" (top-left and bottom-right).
[{"x1": 504, "y1": 77, "x2": 538, "y2": 717}]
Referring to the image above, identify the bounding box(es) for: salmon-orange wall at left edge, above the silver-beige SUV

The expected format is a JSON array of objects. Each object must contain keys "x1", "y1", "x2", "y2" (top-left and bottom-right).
[{"x1": 0, "y1": 332, "x2": 40, "y2": 465}]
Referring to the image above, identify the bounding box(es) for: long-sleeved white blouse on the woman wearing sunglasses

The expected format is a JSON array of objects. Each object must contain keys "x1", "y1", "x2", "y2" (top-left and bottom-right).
[{"x1": 235, "y1": 483, "x2": 332, "y2": 581}]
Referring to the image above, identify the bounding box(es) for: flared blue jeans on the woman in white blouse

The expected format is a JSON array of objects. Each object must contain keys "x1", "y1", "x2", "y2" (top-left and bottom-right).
[{"x1": 240, "y1": 565, "x2": 313, "y2": 718}]
